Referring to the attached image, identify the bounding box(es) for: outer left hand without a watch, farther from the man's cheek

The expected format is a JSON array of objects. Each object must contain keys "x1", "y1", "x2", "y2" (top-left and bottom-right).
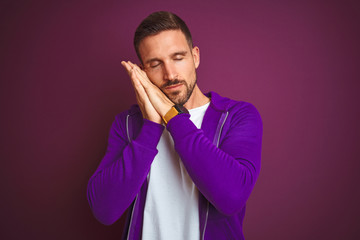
[{"x1": 121, "y1": 61, "x2": 162, "y2": 124}]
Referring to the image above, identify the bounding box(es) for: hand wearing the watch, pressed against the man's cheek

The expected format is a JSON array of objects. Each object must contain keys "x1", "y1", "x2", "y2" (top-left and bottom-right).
[{"x1": 121, "y1": 62, "x2": 174, "y2": 119}]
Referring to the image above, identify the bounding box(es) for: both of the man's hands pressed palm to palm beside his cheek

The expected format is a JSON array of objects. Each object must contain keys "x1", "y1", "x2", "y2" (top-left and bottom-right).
[{"x1": 121, "y1": 61, "x2": 174, "y2": 124}]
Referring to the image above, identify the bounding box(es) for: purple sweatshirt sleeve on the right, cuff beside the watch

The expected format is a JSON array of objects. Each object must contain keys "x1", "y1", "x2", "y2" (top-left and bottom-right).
[{"x1": 167, "y1": 104, "x2": 262, "y2": 215}]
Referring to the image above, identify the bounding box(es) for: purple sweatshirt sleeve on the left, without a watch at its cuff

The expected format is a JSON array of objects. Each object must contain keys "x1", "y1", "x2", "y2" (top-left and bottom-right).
[{"x1": 87, "y1": 117, "x2": 164, "y2": 225}]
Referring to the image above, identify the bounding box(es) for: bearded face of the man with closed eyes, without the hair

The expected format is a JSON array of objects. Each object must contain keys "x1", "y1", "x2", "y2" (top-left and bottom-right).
[{"x1": 139, "y1": 30, "x2": 200, "y2": 105}]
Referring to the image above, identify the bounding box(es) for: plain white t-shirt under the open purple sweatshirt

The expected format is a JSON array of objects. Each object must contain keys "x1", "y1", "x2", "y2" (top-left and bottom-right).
[{"x1": 142, "y1": 103, "x2": 210, "y2": 240}]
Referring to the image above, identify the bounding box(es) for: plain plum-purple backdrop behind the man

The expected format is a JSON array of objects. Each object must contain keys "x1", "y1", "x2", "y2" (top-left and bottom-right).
[{"x1": 0, "y1": 0, "x2": 360, "y2": 240}]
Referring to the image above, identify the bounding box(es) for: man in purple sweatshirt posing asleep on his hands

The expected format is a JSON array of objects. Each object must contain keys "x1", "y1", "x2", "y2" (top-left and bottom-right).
[{"x1": 88, "y1": 12, "x2": 262, "y2": 240}]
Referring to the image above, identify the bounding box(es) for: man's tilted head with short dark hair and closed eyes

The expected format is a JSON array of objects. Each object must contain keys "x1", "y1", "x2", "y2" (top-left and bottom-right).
[{"x1": 134, "y1": 12, "x2": 200, "y2": 105}]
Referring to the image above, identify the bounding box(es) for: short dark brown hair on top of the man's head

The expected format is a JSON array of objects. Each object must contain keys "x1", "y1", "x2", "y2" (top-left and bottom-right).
[{"x1": 134, "y1": 11, "x2": 193, "y2": 62}]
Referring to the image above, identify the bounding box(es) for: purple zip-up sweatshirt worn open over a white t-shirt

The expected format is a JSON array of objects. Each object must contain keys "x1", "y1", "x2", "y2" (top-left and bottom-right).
[{"x1": 87, "y1": 92, "x2": 262, "y2": 240}]
